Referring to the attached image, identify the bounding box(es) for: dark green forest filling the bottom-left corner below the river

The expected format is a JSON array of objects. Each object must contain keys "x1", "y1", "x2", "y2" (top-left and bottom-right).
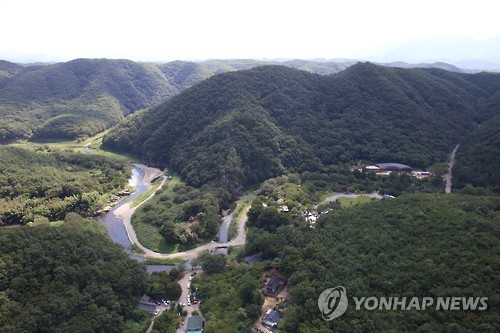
[{"x1": 0, "y1": 221, "x2": 147, "y2": 333}]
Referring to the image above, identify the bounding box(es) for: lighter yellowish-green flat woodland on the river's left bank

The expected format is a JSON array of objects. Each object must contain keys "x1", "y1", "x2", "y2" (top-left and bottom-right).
[{"x1": 0, "y1": 147, "x2": 130, "y2": 226}]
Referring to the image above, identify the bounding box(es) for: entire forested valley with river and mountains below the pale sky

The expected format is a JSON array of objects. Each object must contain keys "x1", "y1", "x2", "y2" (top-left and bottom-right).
[{"x1": 0, "y1": 59, "x2": 500, "y2": 333}]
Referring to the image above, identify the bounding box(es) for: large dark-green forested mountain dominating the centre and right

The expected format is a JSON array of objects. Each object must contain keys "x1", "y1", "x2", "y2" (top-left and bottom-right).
[{"x1": 103, "y1": 63, "x2": 500, "y2": 195}]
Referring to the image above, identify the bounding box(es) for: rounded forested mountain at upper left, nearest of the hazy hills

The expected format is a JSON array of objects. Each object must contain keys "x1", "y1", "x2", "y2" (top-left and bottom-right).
[{"x1": 0, "y1": 59, "x2": 177, "y2": 143}]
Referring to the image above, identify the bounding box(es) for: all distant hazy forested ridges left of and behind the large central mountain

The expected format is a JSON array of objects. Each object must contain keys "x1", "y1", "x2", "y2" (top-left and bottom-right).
[{"x1": 0, "y1": 59, "x2": 352, "y2": 143}]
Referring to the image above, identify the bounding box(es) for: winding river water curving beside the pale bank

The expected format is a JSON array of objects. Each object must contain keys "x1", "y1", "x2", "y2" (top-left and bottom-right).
[{"x1": 96, "y1": 166, "x2": 180, "y2": 273}]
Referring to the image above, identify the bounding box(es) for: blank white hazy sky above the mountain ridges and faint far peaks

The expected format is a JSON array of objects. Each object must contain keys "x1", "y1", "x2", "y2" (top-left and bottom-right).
[{"x1": 0, "y1": 0, "x2": 500, "y2": 61}]
